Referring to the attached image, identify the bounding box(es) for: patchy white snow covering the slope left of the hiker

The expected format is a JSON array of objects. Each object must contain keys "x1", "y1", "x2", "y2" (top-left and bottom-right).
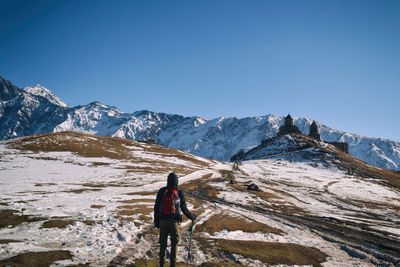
[{"x1": 0, "y1": 143, "x2": 219, "y2": 265}]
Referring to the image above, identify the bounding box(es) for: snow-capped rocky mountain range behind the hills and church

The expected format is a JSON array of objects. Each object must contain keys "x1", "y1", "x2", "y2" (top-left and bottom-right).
[{"x1": 0, "y1": 78, "x2": 400, "y2": 171}]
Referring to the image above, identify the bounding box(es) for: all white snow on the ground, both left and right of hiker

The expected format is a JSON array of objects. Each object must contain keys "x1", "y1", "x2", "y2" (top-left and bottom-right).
[{"x1": 0, "y1": 137, "x2": 400, "y2": 267}]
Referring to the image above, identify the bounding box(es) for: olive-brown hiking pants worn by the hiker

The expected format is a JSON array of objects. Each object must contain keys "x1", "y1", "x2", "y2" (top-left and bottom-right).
[{"x1": 160, "y1": 219, "x2": 181, "y2": 267}]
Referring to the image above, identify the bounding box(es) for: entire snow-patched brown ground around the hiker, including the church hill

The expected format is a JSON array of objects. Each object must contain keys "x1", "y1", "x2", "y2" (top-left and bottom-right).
[{"x1": 0, "y1": 132, "x2": 400, "y2": 266}]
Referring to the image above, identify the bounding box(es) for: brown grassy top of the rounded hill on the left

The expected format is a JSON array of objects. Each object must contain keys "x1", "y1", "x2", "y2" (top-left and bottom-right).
[{"x1": 6, "y1": 132, "x2": 213, "y2": 181}]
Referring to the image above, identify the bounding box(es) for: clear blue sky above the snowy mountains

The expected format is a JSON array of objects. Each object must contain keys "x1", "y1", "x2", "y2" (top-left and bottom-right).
[{"x1": 0, "y1": 0, "x2": 400, "y2": 140}]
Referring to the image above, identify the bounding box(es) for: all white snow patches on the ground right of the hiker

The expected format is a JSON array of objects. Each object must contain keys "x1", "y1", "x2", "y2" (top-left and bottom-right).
[{"x1": 188, "y1": 159, "x2": 400, "y2": 266}]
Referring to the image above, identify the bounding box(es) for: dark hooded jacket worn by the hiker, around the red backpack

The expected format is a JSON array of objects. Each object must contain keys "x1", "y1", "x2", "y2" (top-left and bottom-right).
[{"x1": 154, "y1": 173, "x2": 195, "y2": 225}]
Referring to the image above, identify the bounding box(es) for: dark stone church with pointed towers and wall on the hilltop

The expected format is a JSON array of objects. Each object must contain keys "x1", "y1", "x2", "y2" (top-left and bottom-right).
[{"x1": 277, "y1": 114, "x2": 349, "y2": 153}]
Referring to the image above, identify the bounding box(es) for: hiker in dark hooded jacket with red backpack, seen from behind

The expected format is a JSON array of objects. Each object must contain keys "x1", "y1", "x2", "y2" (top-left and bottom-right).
[{"x1": 154, "y1": 172, "x2": 196, "y2": 267}]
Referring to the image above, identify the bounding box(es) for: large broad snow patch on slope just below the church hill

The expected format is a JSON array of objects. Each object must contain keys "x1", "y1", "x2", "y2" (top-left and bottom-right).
[{"x1": 240, "y1": 159, "x2": 400, "y2": 224}]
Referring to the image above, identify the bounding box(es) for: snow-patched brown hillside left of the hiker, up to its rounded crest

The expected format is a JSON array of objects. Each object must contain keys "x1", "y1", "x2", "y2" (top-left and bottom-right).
[{"x1": 0, "y1": 132, "x2": 216, "y2": 266}]
